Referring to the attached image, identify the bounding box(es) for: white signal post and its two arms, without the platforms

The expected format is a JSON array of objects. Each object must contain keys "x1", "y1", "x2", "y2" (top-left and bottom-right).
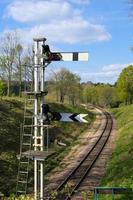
[{"x1": 34, "y1": 38, "x2": 89, "y2": 200}]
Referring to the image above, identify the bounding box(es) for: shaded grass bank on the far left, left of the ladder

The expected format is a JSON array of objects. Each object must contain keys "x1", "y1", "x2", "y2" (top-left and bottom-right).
[{"x1": 0, "y1": 98, "x2": 23, "y2": 194}]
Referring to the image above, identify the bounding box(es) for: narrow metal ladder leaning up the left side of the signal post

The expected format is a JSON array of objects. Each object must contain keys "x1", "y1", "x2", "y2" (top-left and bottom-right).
[{"x1": 16, "y1": 98, "x2": 34, "y2": 195}]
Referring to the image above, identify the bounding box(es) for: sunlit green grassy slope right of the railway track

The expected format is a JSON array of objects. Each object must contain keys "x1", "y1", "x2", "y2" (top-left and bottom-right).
[{"x1": 101, "y1": 105, "x2": 133, "y2": 199}]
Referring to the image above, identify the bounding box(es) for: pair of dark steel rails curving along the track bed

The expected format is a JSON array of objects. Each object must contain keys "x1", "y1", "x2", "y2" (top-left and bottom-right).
[{"x1": 56, "y1": 109, "x2": 113, "y2": 200}]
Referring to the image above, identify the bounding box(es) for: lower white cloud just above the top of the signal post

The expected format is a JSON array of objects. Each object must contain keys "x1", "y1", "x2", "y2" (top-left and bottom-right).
[{"x1": 13, "y1": 18, "x2": 111, "y2": 44}]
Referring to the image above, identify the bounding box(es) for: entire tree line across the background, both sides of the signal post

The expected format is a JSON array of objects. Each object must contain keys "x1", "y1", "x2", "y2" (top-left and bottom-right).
[{"x1": 0, "y1": 32, "x2": 133, "y2": 107}]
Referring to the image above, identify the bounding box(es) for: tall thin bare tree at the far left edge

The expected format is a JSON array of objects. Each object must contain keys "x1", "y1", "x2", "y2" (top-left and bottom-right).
[{"x1": 0, "y1": 32, "x2": 18, "y2": 96}]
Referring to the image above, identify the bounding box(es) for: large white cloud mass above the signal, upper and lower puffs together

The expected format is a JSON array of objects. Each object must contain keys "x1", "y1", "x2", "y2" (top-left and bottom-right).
[{"x1": 5, "y1": 0, "x2": 111, "y2": 44}]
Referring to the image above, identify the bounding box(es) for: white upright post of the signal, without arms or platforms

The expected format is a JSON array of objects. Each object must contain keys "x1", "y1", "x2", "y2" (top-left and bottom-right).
[{"x1": 33, "y1": 38, "x2": 46, "y2": 200}]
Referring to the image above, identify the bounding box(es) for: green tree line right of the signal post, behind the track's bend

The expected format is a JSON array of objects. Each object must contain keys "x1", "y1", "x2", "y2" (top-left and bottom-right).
[{"x1": 45, "y1": 65, "x2": 133, "y2": 107}]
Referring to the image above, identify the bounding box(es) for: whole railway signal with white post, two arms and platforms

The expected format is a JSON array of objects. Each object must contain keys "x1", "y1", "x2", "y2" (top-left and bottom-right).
[{"x1": 16, "y1": 38, "x2": 89, "y2": 200}]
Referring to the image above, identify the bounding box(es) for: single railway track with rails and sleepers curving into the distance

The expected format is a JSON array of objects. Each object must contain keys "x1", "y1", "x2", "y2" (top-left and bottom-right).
[{"x1": 53, "y1": 111, "x2": 113, "y2": 200}]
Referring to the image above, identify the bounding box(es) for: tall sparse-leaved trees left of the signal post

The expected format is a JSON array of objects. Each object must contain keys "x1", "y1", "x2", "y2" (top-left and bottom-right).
[{"x1": 0, "y1": 31, "x2": 33, "y2": 96}]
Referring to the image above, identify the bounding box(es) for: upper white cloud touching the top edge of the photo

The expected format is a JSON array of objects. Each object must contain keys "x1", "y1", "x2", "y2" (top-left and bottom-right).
[{"x1": 7, "y1": 0, "x2": 80, "y2": 23}]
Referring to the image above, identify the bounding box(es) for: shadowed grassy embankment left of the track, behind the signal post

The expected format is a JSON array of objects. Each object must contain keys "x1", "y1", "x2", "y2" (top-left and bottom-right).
[{"x1": 0, "y1": 98, "x2": 95, "y2": 195}]
